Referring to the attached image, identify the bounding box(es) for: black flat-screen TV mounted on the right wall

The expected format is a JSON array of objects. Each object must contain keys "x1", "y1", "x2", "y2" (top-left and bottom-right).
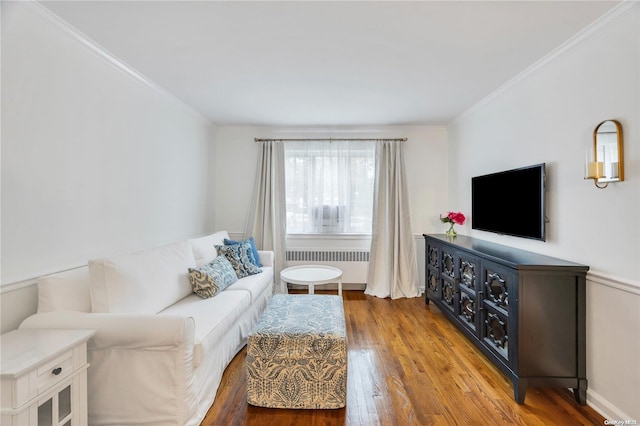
[{"x1": 471, "y1": 163, "x2": 545, "y2": 241}]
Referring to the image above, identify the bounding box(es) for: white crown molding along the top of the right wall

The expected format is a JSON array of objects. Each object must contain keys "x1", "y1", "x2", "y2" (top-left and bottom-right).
[{"x1": 449, "y1": 0, "x2": 640, "y2": 125}]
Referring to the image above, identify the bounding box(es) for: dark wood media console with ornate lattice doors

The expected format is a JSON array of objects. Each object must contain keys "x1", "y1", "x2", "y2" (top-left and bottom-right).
[{"x1": 424, "y1": 235, "x2": 589, "y2": 405}]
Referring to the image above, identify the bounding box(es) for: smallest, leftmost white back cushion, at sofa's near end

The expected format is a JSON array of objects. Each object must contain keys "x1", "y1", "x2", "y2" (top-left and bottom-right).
[{"x1": 36, "y1": 266, "x2": 91, "y2": 314}]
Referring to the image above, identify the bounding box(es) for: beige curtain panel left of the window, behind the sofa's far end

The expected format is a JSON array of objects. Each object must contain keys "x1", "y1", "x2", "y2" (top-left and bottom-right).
[{"x1": 244, "y1": 141, "x2": 287, "y2": 293}]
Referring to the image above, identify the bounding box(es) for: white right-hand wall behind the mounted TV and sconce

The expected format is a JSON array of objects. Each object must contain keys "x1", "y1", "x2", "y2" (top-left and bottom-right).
[{"x1": 448, "y1": 4, "x2": 640, "y2": 420}]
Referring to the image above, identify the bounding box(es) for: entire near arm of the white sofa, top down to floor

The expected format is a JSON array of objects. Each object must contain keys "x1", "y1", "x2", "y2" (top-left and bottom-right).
[{"x1": 19, "y1": 311, "x2": 197, "y2": 425}]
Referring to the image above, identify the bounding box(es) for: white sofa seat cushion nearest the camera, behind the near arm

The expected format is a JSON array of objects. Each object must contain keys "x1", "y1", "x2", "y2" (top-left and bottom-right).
[{"x1": 158, "y1": 291, "x2": 251, "y2": 368}]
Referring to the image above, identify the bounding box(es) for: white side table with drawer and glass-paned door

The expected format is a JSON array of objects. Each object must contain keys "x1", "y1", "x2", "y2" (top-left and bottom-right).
[{"x1": 0, "y1": 330, "x2": 95, "y2": 426}]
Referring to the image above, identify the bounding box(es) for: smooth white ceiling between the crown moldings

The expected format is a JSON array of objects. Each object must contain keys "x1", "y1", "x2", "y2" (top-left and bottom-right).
[{"x1": 43, "y1": 0, "x2": 619, "y2": 126}]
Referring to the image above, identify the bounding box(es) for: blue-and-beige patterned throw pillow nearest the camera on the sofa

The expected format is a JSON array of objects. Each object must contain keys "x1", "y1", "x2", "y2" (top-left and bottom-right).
[{"x1": 189, "y1": 256, "x2": 238, "y2": 299}]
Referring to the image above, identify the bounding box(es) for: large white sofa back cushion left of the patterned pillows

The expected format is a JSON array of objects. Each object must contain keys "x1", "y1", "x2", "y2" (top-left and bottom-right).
[{"x1": 89, "y1": 241, "x2": 195, "y2": 314}]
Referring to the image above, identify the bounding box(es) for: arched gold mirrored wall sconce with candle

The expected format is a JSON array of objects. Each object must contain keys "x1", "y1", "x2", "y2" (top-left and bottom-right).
[{"x1": 584, "y1": 120, "x2": 624, "y2": 189}]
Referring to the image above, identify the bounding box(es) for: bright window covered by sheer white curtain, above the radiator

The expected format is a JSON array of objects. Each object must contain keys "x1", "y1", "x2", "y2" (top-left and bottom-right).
[{"x1": 284, "y1": 141, "x2": 375, "y2": 234}]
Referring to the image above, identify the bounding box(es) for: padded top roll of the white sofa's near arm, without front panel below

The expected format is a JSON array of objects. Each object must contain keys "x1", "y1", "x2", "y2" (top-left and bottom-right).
[{"x1": 19, "y1": 311, "x2": 195, "y2": 350}]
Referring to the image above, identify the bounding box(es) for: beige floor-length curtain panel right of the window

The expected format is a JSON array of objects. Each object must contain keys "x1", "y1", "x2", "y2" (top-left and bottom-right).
[{"x1": 365, "y1": 141, "x2": 420, "y2": 299}]
